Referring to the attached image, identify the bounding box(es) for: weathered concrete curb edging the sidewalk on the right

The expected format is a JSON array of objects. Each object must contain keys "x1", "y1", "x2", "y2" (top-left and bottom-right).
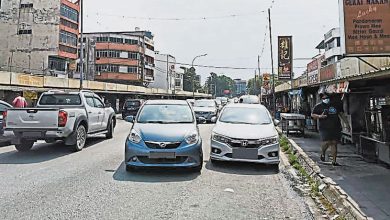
[{"x1": 277, "y1": 128, "x2": 372, "y2": 220}]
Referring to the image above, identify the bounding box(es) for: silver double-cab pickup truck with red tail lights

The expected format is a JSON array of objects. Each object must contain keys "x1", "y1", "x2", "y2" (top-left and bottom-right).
[{"x1": 3, "y1": 90, "x2": 116, "y2": 151}]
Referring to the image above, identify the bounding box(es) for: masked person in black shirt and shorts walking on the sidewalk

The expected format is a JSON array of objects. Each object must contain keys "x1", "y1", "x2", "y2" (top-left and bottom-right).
[{"x1": 311, "y1": 92, "x2": 348, "y2": 166}]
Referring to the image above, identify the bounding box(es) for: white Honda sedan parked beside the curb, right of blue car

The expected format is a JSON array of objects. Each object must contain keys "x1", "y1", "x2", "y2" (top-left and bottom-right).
[{"x1": 210, "y1": 104, "x2": 280, "y2": 167}]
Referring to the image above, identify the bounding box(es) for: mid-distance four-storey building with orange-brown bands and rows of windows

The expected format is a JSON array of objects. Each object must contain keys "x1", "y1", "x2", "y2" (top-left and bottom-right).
[{"x1": 84, "y1": 30, "x2": 155, "y2": 85}]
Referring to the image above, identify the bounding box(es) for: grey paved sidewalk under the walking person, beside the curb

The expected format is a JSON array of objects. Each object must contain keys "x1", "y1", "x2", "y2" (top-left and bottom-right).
[{"x1": 289, "y1": 132, "x2": 390, "y2": 220}]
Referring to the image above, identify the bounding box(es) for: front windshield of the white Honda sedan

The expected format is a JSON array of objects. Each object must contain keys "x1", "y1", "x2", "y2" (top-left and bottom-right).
[{"x1": 219, "y1": 107, "x2": 271, "y2": 124}]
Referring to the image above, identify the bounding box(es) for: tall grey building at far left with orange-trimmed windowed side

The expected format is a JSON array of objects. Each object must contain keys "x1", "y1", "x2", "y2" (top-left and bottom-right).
[{"x1": 0, "y1": 0, "x2": 80, "y2": 78}]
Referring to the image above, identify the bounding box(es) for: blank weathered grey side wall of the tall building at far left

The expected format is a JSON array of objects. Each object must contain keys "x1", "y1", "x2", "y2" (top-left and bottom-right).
[{"x1": 0, "y1": 0, "x2": 60, "y2": 73}]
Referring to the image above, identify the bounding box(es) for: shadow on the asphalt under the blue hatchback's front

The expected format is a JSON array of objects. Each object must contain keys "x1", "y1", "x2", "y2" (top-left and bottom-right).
[{"x1": 113, "y1": 162, "x2": 200, "y2": 183}]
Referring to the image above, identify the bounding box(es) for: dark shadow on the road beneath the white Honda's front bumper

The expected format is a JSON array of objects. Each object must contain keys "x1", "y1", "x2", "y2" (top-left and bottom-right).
[{"x1": 206, "y1": 161, "x2": 279, "y2": 175}]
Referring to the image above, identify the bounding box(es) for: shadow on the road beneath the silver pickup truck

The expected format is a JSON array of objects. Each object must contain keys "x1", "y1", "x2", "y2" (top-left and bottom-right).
[{"x1": 0, "y1": 137, "x2": 105, "y2": 164}]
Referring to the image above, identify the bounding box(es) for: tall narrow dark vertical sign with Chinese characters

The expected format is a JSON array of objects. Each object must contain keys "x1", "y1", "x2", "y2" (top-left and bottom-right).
[{"x1": 278, "y1": 36, "x2": 293, "y2": 80}]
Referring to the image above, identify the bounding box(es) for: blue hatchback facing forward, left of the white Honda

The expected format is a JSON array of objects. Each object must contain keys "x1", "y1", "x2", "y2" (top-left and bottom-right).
[{"x1": 125, "y1": 100, "x2": 203, "y2": 172}]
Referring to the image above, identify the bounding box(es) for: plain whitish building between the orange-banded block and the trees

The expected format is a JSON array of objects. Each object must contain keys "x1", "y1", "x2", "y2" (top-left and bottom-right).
[{"x1": 149, "y1": 52, "x2": 184, "y2": 91}]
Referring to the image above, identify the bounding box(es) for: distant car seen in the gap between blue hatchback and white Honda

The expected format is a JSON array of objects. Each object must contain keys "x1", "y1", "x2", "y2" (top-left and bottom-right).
[{"x1": 194, "y1": 99, "x2": 220, "y2": 122}]
